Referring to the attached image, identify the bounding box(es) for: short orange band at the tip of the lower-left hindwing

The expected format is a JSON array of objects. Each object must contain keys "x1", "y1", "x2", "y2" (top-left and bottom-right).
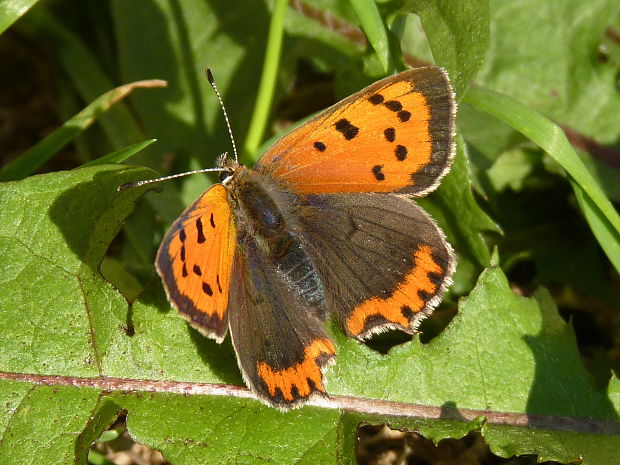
[{"x1": 258, "y1": 338, "x2": 336, "y2": 402}]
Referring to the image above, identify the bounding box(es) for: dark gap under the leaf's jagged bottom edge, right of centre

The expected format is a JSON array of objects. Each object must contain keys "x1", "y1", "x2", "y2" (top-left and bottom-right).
[{"x1": 355, "y1": 424, "x2": 578, "y2": 465}]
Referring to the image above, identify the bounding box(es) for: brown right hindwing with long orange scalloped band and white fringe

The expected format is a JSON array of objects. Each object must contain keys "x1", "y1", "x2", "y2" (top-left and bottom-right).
[{"x1": 301, "y1": 194, "x2": 454, "y2": 339}]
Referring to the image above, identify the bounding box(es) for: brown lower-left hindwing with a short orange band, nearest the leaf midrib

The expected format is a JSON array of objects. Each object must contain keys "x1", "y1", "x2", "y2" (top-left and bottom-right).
[{"x1": 229, "y1": 237, "x2": 335, "y2": 409}]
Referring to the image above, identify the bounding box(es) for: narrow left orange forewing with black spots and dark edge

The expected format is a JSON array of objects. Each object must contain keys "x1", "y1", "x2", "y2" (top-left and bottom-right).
[{"x1": 156, "y1": 184, "x2": 236, "y2": 342}]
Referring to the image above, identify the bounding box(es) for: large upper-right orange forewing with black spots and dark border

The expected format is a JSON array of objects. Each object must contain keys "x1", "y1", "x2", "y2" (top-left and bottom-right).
[{"x1": 257, "y1": 67, "x2": 455, "y2": 195}]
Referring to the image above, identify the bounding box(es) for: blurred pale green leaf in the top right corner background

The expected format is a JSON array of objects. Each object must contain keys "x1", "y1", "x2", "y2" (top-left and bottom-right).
[{"x1": 476, "y1": 0, "x2": 620, "y2": 144}]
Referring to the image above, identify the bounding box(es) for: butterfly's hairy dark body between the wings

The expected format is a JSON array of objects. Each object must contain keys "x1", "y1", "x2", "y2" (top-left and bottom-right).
[{"x1": 225, "y1": 166, "x2": 324, "y2": 313}]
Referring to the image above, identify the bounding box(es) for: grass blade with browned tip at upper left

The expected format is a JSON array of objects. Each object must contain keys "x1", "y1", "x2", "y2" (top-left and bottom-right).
[{"x1": 0, "y1": 80, "x2": 166, "y2": 181}]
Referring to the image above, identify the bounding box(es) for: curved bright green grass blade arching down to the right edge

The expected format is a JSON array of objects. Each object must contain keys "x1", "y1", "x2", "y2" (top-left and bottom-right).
[{"x1": 465, "y1": 88, "x2": 620, "y2": 271}]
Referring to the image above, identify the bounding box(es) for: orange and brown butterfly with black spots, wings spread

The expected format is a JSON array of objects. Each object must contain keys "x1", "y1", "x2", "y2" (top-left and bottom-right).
[{"x1": 156, "y1": 67, "x2": 456, "y2": 410}]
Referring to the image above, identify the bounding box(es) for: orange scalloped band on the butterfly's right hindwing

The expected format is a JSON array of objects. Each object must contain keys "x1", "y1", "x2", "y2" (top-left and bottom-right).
[{"x1": 346, "y1": 245, "x2": 446, "y2": 336}]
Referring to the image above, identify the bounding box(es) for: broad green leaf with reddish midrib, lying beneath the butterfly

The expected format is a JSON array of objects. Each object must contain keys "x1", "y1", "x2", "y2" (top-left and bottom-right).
[{"x1": 0, "y1": 166, "x2": 620, "y2": 465}]
